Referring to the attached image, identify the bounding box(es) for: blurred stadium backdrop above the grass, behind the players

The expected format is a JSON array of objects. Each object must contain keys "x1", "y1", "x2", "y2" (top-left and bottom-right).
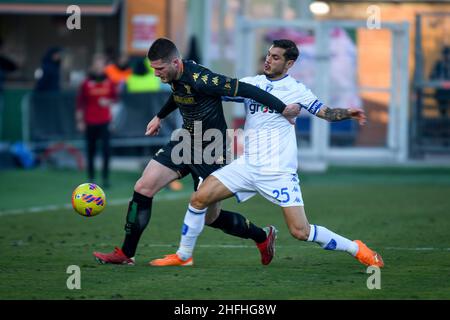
[{"x1": 0, "y1": 0, "x2": 450, "y2": 169}]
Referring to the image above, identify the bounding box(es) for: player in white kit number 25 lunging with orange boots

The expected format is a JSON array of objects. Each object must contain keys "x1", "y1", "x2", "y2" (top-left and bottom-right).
[{"x1": 150, "y1": 40, "x2": 384, "y2": 267}]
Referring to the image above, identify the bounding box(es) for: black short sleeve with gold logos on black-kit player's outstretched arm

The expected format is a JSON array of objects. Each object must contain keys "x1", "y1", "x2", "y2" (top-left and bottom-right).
[{"x1": 191, "y1": 68, "x2": 238, "y2": 97}]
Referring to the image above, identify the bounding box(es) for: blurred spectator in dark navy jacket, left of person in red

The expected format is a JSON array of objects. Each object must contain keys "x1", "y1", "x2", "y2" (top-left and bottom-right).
[{"x1": 35, "y1": 47, "x2": 62, "y2": 91}]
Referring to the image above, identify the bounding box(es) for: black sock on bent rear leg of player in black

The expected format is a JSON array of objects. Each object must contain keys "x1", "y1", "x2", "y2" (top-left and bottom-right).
[{"x1": 209, "y1": 210, "x2": 267, "y2": 243}]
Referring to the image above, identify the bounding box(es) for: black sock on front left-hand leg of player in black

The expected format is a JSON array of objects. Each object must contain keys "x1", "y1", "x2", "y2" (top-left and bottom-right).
[{"x1": 122, "y1": 191, "x2": 153, "y2": 258}]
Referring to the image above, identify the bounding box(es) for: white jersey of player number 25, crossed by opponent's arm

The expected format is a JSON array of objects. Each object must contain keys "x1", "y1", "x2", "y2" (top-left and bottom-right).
[{"x1": 239, "y1": 75, "x2": 322, "y2": 173}]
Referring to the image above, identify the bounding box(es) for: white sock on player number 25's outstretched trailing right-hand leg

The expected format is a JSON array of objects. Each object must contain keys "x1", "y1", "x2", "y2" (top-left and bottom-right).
[{"x1": 307, "y1": 224, "x2": 358, "y2": 256}]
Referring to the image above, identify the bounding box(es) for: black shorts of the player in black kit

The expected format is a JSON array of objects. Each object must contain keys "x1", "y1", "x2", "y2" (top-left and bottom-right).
[{"x1": 153, "y1": 141, "x2": 225, "y2": 190}]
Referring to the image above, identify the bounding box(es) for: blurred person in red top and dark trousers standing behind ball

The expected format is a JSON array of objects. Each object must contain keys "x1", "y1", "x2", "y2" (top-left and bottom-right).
[{"x1": 76, "y1": 56, "x2": 117, "y2": 188}]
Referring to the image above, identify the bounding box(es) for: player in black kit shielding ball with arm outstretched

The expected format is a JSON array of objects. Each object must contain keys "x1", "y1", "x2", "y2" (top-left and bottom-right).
[{"x1": 94, "y1": 38, "x2": 299, "y2": 265}]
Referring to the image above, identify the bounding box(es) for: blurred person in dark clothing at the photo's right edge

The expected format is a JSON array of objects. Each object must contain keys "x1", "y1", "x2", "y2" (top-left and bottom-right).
[{"x1": 431, "y1": 46, "x2": 450, "y2": 117}]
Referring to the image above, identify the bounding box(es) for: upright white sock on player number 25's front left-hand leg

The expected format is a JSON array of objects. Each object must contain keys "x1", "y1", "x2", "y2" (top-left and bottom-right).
[{"x1": 177, "y1": 204, "x2": 206, "y2": 260}]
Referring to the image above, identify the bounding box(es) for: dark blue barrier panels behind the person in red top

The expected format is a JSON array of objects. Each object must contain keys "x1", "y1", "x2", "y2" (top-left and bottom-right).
[{"x1": 22, "y1": 91, "x2": 181, "y2": 149}]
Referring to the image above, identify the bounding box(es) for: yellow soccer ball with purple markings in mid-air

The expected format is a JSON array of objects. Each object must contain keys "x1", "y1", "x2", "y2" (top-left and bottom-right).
[{"x1": 72, "y1": 183, "x2": 106, "y2": 217}]
